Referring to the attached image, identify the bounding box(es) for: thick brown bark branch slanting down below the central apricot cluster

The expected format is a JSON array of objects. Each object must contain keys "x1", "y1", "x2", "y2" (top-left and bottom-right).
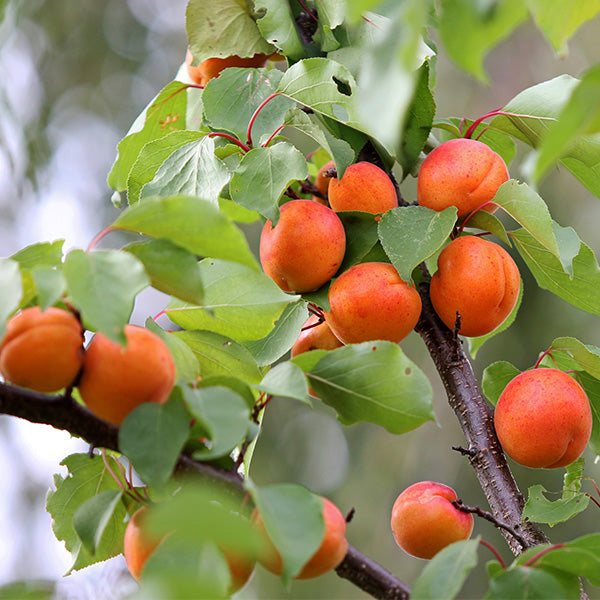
[{"x1": 415, "y1": 283, "x2": 548, "y2": 555}]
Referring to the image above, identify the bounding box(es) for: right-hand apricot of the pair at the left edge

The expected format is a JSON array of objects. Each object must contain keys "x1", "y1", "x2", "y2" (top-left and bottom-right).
[{"x1": 79, "y1": 325, "x2": 176, "y2": 425}]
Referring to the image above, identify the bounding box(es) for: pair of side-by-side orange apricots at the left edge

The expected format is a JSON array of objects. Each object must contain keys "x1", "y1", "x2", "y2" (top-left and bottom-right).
[{"x1": 0, "y1": 306, "x2": 176, "y2": 425}]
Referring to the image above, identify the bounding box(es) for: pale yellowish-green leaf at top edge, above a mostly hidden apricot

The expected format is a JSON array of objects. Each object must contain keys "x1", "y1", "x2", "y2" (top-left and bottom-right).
[{"x1": 185, "y1": 0, "x2": 274, "y2": 62}]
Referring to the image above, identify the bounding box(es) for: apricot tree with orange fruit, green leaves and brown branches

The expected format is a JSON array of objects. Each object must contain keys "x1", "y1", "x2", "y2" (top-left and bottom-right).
[{"x1": 0, "y1": 0, "x2": 600, "y2": 599}]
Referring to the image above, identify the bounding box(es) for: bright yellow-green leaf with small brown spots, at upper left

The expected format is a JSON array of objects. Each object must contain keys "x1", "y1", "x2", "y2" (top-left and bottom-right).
[{"x1": 108, "y1": 81, "x2": 187, "y2": 192}]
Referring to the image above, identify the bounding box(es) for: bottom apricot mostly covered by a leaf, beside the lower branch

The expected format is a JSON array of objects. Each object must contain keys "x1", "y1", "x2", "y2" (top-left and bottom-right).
[{"x1": 252, "y1": 497, "x2": 348, "y2": 579}]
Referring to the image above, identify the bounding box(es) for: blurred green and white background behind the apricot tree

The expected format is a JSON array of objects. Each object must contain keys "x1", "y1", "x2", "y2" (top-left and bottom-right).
[{"x1": 0, "y1": 0, "x2": 600, "y2": 600}]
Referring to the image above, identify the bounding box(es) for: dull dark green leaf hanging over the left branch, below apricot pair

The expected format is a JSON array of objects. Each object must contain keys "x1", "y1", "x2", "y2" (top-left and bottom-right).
[{"x1": 119, "y1": 400, "x2": 190, "y2": 485}]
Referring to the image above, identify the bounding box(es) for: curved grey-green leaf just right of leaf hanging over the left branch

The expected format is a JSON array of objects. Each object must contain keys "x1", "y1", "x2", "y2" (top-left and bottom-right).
[{"x1": 185, "y1": 386, "x2": 250, "y2": 460}]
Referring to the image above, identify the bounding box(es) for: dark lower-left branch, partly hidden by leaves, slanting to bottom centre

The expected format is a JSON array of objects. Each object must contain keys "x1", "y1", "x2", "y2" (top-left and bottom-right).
[{"x1": 0, "y1": 383, "x2": 409, "y2": 600}]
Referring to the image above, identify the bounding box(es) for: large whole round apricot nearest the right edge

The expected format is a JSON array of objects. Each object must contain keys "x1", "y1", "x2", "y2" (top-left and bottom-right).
[{"x1": 494, "y1": 368, "x2": 592, "y2": 469}]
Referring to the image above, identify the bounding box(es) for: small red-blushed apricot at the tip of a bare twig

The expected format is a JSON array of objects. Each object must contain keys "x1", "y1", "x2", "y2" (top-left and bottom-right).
[{"x1": 391, "y1": 481, "x2": 473, "y2": 559}]
